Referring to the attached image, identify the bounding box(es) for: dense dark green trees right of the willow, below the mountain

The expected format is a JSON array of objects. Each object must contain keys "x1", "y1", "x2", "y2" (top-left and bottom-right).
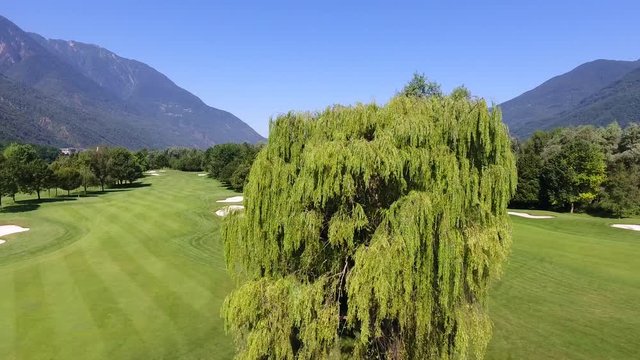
[{"x1": 512, "y1": 123, "x2": 640, "y2": 217}]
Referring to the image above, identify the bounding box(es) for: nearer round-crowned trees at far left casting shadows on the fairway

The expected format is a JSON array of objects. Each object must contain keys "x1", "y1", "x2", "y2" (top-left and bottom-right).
[{"x1": 0, "y1": 144, "x2": 143, "y2": 204}]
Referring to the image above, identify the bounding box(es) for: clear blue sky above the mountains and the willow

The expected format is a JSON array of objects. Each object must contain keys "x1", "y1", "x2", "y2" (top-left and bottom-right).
[{"x1": 0, "y1": 0, "x2": 640, "y2": 135}]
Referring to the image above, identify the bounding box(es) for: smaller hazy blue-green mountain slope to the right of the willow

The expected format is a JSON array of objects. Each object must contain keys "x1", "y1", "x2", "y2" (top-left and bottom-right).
[{"x1": 500, "y1": 60, "x2": 640, "y2": 137}]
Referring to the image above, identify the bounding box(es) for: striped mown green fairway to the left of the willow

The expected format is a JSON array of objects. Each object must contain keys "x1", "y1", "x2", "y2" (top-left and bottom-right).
[{"x1": 0, "y1": 171, "x2": 234, "y2": 360}]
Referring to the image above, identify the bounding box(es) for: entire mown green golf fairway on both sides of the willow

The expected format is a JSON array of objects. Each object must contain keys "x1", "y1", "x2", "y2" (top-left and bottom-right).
[{"x1": 0, "y1": 170, "x2": 640, "y2": 360}]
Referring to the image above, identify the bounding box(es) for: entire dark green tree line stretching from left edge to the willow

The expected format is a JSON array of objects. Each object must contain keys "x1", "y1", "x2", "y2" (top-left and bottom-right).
[{"x1": 0, "y1": 144, "x2": 260, "y2": 205}]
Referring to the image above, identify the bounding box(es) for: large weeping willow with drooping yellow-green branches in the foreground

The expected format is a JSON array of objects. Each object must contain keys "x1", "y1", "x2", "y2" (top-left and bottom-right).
[{"x1": 222, "y1": 96, "x2": 516, "y2": 359}]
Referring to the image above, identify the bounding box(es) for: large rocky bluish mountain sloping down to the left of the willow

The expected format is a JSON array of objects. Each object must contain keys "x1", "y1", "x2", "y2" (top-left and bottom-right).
[{"x1": 0, "y1": 16, "x2": 262, "y2": 148}]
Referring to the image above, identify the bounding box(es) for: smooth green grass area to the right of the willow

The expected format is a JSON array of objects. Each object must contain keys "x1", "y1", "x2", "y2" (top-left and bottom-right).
[{"x1": 487, "y1": 212, "x2": 640, "y2": 359}]
